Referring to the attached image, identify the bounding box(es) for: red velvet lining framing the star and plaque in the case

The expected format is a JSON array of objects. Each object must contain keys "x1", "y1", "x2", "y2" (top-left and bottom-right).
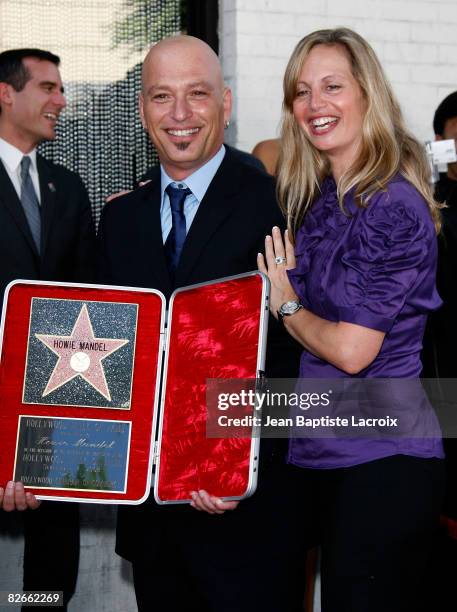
[{"x1": 0, "y1": 283, "x2": 162, "y2": 500}]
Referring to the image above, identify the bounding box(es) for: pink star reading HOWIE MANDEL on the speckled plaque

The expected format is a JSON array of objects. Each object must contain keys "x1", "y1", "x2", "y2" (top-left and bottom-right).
[{"x1": 35, "y1": 304, "x2": 129, "y2": 401}]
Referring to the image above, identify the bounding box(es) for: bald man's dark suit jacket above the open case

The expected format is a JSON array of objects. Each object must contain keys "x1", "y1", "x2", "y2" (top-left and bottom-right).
[{"x1": 98, "y1": 150, "x2": 278, "y2": 298}]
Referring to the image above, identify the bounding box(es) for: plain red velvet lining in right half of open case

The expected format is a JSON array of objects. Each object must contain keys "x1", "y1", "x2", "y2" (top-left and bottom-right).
[{"x1": 158, "y1": 275, "x2": 262, "y2": 501}]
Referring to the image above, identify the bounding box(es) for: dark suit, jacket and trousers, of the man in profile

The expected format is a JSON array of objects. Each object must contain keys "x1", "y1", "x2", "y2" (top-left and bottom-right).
[{"x1": 0, "y1": 155, "x2": 95, "y2": 610}]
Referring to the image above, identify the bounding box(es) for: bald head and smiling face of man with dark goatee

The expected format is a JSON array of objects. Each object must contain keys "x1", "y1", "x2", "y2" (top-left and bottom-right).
[{"x1": 139, "y1": 36, "x2": 231, "y2": 180}]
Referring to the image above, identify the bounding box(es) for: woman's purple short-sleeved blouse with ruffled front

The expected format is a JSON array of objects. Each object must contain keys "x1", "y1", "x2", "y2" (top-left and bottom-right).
[{"x1": 288, "y1": 175, "x2": 443, "y2": 468}]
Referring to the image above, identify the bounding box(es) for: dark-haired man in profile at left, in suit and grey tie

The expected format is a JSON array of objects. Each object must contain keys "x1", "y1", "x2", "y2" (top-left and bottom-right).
[{"x1": 0, "y1": 49, "x2": 95, "y2": 610}]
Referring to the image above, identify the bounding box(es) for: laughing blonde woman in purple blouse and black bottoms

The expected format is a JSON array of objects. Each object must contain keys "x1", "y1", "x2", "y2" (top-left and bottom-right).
[{"x1": 259, "y1": 28, "x2": 443, "y2": 612}]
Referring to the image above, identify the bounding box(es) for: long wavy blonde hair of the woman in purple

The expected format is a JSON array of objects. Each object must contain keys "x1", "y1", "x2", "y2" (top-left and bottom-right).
[{"x1": 278, "y1": 28, "x2": 441, "y2": 237}]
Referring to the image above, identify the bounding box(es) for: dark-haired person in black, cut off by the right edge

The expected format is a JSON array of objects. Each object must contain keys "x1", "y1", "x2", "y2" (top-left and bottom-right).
[{"x1": 422, "y1": 91, "x2": 457, "y2": 612}]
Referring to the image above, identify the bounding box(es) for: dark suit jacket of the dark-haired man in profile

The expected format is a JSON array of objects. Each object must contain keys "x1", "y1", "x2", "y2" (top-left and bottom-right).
[{"x1": 0, "y1": 155, "x2": 94, "y2": 310}]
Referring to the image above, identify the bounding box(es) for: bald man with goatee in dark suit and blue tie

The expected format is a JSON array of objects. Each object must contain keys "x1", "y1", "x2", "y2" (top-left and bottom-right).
[{"x1": 99, "y1": 36, "x2": 301, "y2": 612}]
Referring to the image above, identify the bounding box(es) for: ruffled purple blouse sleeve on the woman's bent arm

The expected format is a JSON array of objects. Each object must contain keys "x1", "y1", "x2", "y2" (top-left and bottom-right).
[{"x1": 338, "y1": 192, "x2": 440, "y2": 332}]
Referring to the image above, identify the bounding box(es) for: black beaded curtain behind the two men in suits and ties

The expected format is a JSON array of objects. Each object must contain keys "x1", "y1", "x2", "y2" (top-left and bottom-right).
[{"x1": 0, "y1": 0, "x2": 180, "y2": 221}]
